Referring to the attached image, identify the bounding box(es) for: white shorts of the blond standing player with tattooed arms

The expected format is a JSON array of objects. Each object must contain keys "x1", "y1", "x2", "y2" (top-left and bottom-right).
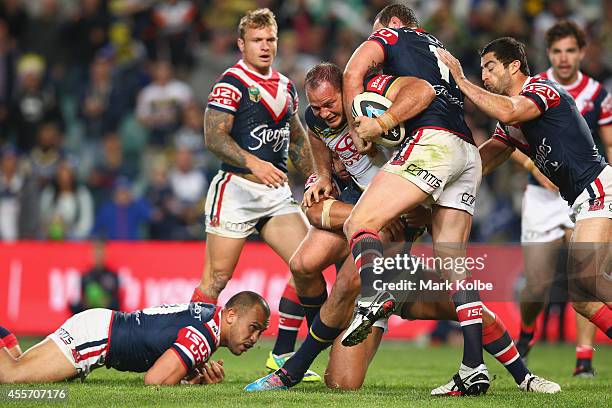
[{"x1": 205, "y1": 170, "x2": 306, "y2": 238}]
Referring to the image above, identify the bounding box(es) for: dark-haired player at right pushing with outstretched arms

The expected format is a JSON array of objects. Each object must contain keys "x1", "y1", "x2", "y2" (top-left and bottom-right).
[{"x1": 438, "y1": 37, "x2": 612, "y2": 338}]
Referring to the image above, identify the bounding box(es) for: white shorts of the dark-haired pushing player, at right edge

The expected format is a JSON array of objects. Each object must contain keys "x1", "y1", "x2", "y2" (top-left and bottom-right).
[{"x1": 572, "y1": 166, "x2": 612, "y2": 222}]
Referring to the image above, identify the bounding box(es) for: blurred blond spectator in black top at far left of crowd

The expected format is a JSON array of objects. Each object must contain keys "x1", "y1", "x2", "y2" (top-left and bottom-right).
[{"x1": 9, "y1": 54, "x2": 64, "y2": 152}]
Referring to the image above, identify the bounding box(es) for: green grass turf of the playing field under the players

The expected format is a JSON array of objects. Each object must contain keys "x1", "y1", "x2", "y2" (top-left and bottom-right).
[{"x1": 0, "y1": 342, "x2": 612, "y2": 408}]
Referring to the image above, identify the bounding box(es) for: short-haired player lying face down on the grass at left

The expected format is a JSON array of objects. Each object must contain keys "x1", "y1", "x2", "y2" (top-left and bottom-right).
[{"x1": 0, "y1": 291, "x2": 270, "y2": 384}]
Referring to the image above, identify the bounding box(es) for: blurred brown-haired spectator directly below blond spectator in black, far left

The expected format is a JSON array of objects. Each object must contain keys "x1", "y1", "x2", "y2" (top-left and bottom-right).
[{"x1": 28, "y1": 122, "x2": 64, "y2": 189}]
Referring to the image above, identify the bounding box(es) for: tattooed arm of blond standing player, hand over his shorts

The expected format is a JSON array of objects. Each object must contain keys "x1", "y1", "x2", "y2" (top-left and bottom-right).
[{"x1": 204, "y1": 109, "x2": 287, "y2": 187}]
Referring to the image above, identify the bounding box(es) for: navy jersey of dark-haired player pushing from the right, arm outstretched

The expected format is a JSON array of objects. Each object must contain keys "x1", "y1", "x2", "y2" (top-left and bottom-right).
[{"x1": 493, "y1": 77, "x2": 606, "y2": 205}]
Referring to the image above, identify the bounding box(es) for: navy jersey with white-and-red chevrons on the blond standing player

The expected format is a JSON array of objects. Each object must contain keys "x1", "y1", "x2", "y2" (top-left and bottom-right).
[{"x1": 207, "y1": 60, "x2": 298, "y2": 173}]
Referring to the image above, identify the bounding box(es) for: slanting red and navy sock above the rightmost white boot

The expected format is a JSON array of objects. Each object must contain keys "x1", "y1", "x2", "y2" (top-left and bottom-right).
[{"x1": 482, "y1": 310, "x2": 529, "y2": 384}]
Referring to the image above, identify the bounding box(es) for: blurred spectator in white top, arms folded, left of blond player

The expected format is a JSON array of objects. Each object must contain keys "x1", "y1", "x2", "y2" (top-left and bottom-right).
[{"x1": 136, "y1": 61, "x2": 193, "y2": 146}]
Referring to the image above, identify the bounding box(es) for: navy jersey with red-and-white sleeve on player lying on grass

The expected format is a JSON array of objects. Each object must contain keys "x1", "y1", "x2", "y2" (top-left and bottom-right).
[{"x1": 106, "y1": 302, "x2": 221, "y2": 372}]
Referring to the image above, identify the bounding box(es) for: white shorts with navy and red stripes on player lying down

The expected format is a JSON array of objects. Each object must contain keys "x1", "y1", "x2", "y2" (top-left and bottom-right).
[{"x1": 47, "y1": 309, "x2": 114, "y2": 378}]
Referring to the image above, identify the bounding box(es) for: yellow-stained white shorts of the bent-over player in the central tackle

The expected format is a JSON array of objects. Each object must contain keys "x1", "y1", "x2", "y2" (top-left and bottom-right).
[{"x1": 382, "y1": 128, "x2": 482, "y2": 215}]
